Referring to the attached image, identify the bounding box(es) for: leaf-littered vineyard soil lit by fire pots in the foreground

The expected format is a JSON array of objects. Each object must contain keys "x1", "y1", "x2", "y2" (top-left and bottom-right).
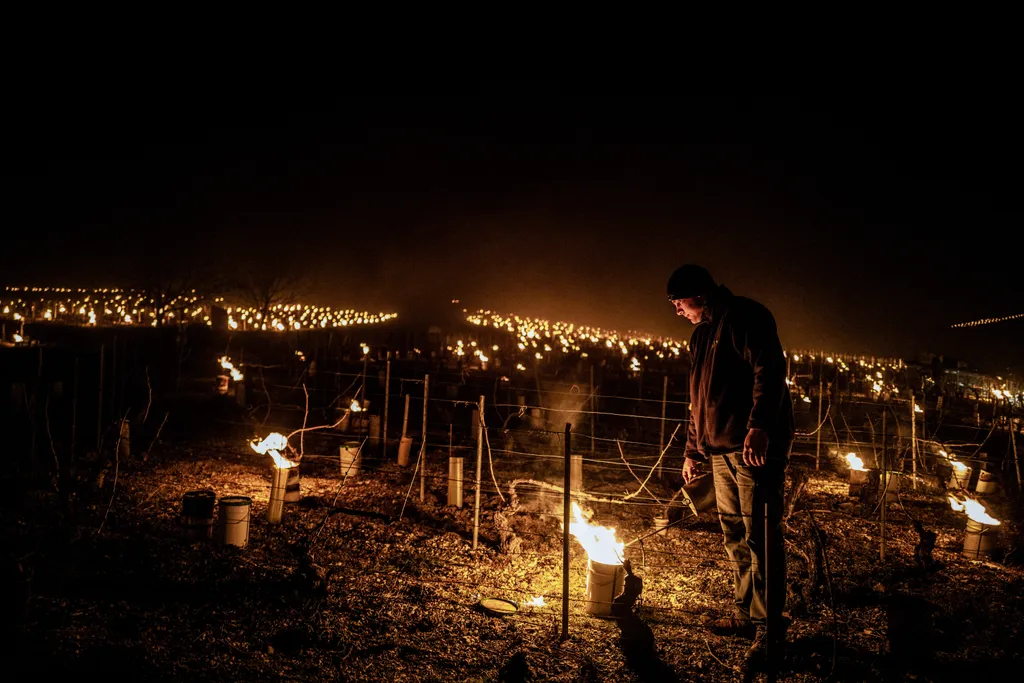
[{"x1": 4, "y1": 442, "x2": 1024, "y2": 682}]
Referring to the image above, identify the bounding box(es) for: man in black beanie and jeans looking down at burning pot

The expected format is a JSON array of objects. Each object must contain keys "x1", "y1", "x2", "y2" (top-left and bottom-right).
[{"x1": 668, "y1": 264, "x2": 795, "y2": 668}]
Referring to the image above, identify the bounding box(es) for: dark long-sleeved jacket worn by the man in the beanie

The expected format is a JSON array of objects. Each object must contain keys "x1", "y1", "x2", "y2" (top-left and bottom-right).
[{"x1": 685, "y1": 287, "x2": 795, "y2": 461}]
